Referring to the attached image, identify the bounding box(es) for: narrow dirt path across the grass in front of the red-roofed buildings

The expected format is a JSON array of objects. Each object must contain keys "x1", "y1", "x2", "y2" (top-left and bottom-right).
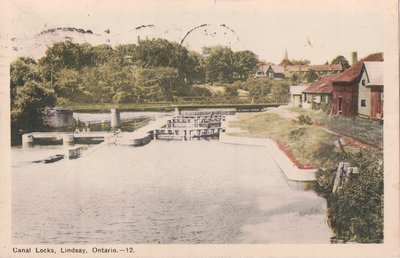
[{"x1": 266, "y1": 105, "x2": 383, "y2": 152}]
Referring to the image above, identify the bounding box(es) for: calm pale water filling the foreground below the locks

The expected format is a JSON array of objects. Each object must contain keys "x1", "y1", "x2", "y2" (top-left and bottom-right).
[{"x1": 12, "y1": 141, "x2": 330, "y2": 244}]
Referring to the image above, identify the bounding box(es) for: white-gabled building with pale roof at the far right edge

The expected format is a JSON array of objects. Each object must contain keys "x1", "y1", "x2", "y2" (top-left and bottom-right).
[{"x1": 358, "y1": 61, "x2": 383, "y2": 119}]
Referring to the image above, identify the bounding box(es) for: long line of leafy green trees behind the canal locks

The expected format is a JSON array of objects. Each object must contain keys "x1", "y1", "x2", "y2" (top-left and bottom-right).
[{"x1": 11, "y1": 39, "x2": 258, "y2": 105}]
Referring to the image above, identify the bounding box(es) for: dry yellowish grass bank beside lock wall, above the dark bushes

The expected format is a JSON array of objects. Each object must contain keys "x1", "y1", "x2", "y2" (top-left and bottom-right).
[{"x1": 227, "y1": 106, "x2": 383, "y2": 169}]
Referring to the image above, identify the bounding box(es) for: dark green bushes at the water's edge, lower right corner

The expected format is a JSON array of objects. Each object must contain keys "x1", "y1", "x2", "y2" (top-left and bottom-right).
[{"x1": 315, "y1": 150, "x2": 383, "y2": 243}]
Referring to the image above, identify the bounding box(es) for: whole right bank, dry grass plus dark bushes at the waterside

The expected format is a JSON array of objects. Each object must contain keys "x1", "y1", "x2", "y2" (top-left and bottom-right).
[{"x1": 229, "y1": 110, "x2": 384, "y2": 243}]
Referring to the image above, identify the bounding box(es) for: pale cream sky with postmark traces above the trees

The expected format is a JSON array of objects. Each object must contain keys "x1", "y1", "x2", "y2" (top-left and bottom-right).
[{"x1": 3, "y1": 0, "x2": 385, "y2": 64}]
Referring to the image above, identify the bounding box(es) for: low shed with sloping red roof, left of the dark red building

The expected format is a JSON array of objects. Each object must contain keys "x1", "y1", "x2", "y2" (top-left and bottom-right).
[{"x1": 303, "y1": 74, "x2": 336, "y2": 111}]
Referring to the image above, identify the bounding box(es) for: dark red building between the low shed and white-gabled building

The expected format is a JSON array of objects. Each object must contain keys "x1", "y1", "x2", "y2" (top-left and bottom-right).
[{"x1": 332, "y1": 53, "x2": 383, "y2": 117}]
